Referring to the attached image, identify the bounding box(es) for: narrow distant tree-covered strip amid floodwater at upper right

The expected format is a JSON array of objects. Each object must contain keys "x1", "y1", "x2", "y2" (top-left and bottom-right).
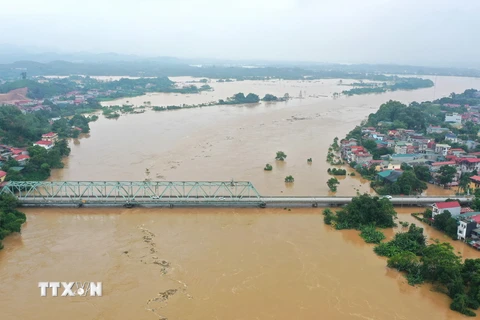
[{"x1": 342, "y1": 76, "x2": 434, "y2": 96}]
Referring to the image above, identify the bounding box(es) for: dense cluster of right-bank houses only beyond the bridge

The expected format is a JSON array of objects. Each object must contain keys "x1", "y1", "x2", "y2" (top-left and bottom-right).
[{"x1": 340, "y1": 107, "x2": 480, "y2": 192}]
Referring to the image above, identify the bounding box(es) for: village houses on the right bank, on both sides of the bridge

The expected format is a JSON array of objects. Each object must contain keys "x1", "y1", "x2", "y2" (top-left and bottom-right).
[{"x1": 338, "y1": 92, "x2": 480, "y2": 250}]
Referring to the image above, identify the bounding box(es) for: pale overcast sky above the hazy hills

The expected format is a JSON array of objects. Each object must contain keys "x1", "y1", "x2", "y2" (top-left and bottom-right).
[{"x1": 0, "y1": 0, "x2": 480, "y2": 66}]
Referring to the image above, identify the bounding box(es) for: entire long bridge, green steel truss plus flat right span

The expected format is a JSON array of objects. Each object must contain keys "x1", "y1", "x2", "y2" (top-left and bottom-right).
[{"x1": 0, "y1": 180, "x2": 472, "y2": 208}]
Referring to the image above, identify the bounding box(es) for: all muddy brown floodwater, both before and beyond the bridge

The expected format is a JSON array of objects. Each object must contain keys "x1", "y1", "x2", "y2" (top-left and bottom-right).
[{"x1": 0, "y1": 77, "x2": 480, "y2": 320}]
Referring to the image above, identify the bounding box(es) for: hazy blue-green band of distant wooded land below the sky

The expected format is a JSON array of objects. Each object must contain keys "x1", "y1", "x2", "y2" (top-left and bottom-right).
[{"x1": 0, "y1": 57, "x2": 480, "y2": 81}]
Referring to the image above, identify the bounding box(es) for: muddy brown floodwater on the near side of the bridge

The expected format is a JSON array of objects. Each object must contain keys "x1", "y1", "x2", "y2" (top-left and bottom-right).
[{"x1": 0, "y1": 209, "x2": 480, "y2": 320}]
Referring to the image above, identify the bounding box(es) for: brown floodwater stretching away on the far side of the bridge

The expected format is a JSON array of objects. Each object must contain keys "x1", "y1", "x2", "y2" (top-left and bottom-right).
[{"x1": 51, "y1": 77, "x2": 480, "y2": 195}]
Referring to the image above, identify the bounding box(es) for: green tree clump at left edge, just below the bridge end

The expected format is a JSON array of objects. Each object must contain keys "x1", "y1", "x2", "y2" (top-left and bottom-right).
[{"x1": 0, "y1": 194, "x2": 27, "y2": 250}]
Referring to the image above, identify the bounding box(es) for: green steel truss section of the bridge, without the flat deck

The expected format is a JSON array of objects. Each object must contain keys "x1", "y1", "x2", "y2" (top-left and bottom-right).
[{"x1": 0, "y1": 181, "x2": 261, "y2": 205}]
